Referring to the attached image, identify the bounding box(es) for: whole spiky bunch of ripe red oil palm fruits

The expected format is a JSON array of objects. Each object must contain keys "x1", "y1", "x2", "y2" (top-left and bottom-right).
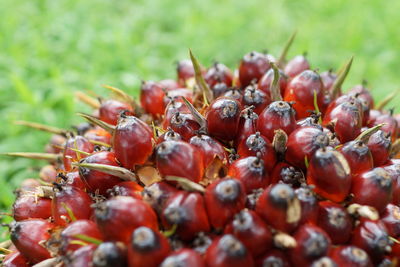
[{"x1": 2, "y1": 36, "x2": 400, "y2": 267}]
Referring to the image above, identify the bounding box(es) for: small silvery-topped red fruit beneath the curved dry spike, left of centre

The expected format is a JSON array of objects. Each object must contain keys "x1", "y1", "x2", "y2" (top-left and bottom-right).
[{"x1": 169, "y1": 112, "x2": 200, "y2": 141}]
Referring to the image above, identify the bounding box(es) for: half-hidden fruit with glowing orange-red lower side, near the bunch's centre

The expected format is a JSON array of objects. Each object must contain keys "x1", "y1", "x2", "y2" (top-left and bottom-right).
[{"x1": 189, "y1": 134, "x2": 228, "y2": 168}]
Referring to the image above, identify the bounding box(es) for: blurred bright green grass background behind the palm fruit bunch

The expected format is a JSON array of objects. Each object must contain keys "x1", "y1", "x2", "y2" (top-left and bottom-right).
[{"x1": 0, "y1": 0, "x2": 400, "y2": 232}]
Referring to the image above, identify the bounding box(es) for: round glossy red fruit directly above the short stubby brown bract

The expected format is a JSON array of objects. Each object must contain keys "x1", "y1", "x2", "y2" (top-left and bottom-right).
[{"x1": 257, "y1": 101, "x2": 297, "y2": 140}]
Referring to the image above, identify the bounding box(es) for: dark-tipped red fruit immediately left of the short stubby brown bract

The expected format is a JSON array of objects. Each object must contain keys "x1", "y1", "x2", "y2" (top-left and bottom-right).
[{"x1": 237, "y1": 132, "x2": 276, "y2": 172}]
